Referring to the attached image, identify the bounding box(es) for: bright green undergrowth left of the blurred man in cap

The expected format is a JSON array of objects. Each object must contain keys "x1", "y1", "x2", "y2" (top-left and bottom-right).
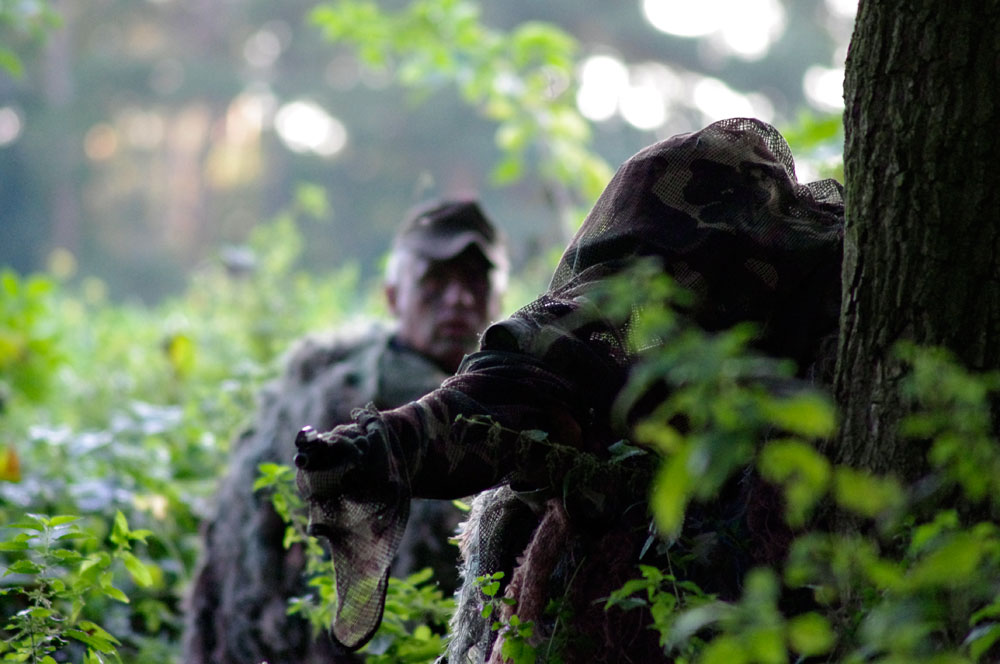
[{"x1": 0, "y1": 205, "x2": 372, "y2": 663}]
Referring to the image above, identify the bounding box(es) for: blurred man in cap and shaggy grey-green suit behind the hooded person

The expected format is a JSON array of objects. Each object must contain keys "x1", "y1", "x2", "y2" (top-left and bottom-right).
[{"x1": 183, "y1": 200, "x2": 507, "y2": 664}]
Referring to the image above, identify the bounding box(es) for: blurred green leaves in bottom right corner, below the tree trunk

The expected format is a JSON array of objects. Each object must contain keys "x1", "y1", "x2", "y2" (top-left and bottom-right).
[{"x1": 609, "y1": 338, "x2": 1000, "y2": 663}]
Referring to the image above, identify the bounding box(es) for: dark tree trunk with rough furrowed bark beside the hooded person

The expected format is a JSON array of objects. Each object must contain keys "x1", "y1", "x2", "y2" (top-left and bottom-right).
[{"x1": 834, "y1": 0, "x2": 1000, "y2": 477}]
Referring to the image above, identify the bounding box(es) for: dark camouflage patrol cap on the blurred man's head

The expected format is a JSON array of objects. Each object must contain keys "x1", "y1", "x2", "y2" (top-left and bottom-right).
[{"x1": 394, "y1": 199, "x2": 507, "y2": 268}]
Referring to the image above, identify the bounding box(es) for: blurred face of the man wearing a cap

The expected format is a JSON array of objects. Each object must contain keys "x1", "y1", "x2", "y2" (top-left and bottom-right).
[{"x1": 386, "y1": 248, "x2": 499, "y2": 371}]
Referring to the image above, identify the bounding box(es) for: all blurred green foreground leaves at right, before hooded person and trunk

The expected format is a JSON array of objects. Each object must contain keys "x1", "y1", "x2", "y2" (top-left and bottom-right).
[{"x1": 584, "y1": 266, "x2": 1000, "y2": 663}]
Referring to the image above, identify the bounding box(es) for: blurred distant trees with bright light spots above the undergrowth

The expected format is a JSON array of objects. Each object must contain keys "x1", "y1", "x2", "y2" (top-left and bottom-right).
[{"x1": 0, "y1": 0, "x2": 853, "y2": 303}]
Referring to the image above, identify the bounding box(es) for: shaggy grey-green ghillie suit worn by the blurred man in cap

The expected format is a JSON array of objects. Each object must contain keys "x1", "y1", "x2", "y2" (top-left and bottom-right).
[{"x1": 183, "y1": 327, "x2": 461, "y2": 664}]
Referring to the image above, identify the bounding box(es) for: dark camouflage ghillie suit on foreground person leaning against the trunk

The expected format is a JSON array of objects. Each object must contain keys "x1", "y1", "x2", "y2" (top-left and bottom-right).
[{"x1": 295, "y1": 119, "x2": 843, "y2": 664}]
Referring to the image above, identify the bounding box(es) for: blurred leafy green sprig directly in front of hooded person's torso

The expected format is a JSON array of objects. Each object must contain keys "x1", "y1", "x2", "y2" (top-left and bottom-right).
[{"x1": 598, "y1": 264, "x2": 835, "y2": 535}]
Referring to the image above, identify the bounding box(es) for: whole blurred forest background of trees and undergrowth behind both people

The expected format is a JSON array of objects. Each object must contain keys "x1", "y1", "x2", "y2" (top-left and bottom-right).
[{"x1": 9, "y1": 0, "x2": 997, "y2": 662}]
